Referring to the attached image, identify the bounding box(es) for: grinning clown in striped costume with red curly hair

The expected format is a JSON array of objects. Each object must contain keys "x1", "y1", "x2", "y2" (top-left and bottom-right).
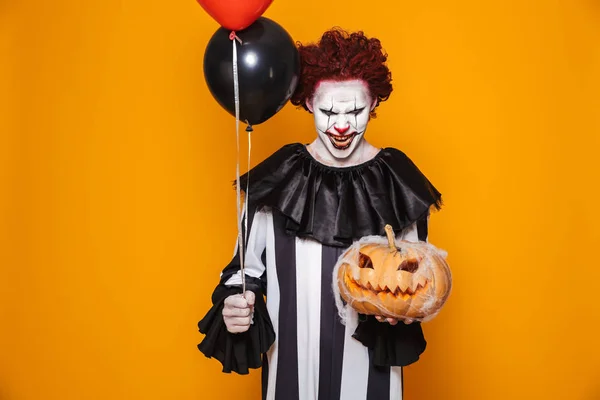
[{"x1": 198, "y1": 30, "x2": 441, "y2": 400}]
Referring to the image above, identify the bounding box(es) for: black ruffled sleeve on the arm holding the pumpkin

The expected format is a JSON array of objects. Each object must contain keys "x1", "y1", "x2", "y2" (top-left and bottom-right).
[{"x1": 352, "y1": 218, "x2": 428, "y2": 367}]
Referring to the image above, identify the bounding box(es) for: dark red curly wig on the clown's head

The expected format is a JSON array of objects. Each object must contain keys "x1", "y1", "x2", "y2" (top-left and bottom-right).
[{"x1": 290, "y1": 28, "x2": 392, "y2": 117}]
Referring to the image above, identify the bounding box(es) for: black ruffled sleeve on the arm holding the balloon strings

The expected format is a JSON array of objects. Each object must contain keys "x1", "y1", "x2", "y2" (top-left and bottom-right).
[{"x1": 198, "y1": 209, "x2": 275, "y2": 375}]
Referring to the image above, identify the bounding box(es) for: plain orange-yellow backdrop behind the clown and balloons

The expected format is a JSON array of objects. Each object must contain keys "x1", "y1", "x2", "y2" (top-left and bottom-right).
[{"x1": 0, "y1": 0, "x2": 600, "y2": 400}]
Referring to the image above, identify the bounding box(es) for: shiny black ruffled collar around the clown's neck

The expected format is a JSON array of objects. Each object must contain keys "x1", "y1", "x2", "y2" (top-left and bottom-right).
[{"x1": 240, "y1": 143, "x2": 442, "y2": 247}]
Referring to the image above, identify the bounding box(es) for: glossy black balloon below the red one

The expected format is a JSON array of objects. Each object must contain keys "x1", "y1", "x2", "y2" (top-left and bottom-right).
[{"x1": 204, "y1": 17, "x2": 300, "y2": 125}]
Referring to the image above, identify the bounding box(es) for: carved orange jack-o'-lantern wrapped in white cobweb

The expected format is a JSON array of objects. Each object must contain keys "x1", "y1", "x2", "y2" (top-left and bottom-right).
[{"x1": 334, "y1": 225, "x2": 452, "y2": 321}]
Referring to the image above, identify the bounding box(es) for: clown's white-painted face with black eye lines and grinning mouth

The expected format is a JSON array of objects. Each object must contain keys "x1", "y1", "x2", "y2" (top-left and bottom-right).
[{"x1": 307, "y1": 80, "x2": 375, "y2": 159}]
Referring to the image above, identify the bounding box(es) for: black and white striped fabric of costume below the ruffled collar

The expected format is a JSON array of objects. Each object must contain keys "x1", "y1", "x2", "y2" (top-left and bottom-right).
[{"x1": 226, "y1": 210, "x2": 427, "y2": 400}]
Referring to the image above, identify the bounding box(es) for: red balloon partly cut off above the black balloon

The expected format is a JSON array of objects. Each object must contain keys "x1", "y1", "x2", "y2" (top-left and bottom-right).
[{"x1": 197, "y1": 0, "x2": 273, "y2": 31}]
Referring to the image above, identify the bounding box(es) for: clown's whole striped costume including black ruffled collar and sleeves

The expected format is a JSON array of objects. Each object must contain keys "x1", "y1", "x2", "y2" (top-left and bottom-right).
[{"x1": 199, "y1": 144, "x2": 441, "y2": 400}]
